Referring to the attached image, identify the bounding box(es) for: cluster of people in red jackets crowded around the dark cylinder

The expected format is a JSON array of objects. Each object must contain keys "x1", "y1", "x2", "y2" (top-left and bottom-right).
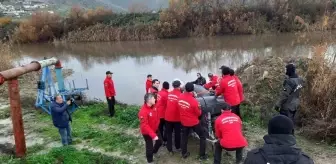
[{"x1": 139, "y1": 66, "x2": 247, "y2": 163}]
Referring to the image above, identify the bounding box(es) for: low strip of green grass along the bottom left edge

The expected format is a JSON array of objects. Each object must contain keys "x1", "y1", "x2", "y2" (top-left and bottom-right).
[{"x1": 0, "y1": 147, "x2": 129, "y2": 164}]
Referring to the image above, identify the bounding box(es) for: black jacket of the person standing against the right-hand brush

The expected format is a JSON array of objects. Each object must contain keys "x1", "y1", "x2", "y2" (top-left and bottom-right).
[{"x1": 276, "y1": 75, "x2": 303, "y2": 111}]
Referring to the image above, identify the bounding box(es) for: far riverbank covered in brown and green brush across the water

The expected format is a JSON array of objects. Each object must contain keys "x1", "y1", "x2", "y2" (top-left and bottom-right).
[{"x1": 0, "y1": 0, "x2": 336, "y2": 43}]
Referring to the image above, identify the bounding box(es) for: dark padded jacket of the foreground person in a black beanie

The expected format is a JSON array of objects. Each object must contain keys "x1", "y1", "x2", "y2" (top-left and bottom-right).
[{"x1": 244, "y1": 134, "x2": 314, "y2": 164}]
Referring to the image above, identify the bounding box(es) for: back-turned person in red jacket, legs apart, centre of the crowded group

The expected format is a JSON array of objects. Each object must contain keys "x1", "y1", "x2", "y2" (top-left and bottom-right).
[{"x1": 178, "y1": 83, "x2": 207, "y2": 160}]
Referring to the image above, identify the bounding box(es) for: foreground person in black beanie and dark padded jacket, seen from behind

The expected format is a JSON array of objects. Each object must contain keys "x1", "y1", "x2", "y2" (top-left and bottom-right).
[{"x1": 244, "y1": 115, "x2": 314, "y2": 164}]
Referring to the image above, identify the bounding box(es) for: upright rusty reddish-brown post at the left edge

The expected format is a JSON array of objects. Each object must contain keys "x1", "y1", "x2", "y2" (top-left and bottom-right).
[{"x1": 8, "y1": 77, "x2": 26, "y2": 157}]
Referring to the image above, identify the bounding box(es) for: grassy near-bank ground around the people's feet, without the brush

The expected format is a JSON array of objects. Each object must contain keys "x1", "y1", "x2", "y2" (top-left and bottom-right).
[{"x1": 0, "y1": 103, "x2": 336, "y2": 164}]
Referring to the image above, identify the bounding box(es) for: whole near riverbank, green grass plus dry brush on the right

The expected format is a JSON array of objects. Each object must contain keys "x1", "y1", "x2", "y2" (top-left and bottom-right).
[{"x1": 0, "y1": 49, "x2": 336, "y2": 164}]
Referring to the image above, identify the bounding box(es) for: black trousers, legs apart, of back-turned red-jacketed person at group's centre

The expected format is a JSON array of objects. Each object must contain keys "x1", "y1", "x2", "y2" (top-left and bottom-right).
[{"x1": 182, "y1": 123, "x2": 206, "y2": 157}]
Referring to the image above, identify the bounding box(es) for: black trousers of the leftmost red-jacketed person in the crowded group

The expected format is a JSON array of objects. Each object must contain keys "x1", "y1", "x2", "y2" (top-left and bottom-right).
[{"x1": 143, "y1": 133, "x2": 162, "y2": 163}]
